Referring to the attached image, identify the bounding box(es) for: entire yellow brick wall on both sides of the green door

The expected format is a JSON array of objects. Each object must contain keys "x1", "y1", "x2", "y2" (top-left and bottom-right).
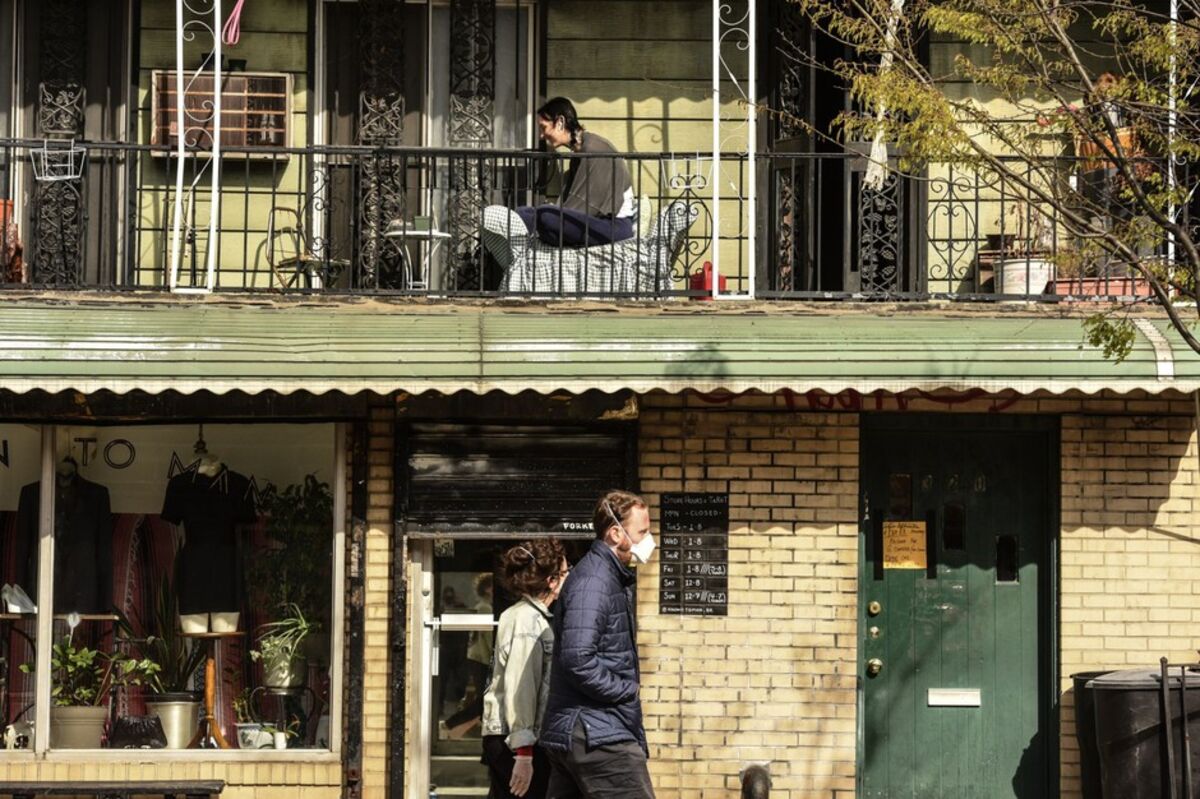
[{"x1": 638, "y1": 394, "x2": 1200, "y2": 799}]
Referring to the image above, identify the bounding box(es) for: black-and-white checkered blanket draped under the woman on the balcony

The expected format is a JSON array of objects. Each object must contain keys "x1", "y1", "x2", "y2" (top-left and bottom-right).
[{"x1": 480, "y1": 200, "x2": 700, "y2": 298}]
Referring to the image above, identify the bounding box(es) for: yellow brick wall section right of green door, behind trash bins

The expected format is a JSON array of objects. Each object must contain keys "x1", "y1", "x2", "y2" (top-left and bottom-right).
[{"x1": 1060, "y1": 398, "x2": 1200, "y2": 798}]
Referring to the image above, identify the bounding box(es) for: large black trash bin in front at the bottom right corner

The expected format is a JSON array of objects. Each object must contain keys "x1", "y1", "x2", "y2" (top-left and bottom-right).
[{"x1": 1085, "y1": 668, "x2": 1200, "y2": 799}]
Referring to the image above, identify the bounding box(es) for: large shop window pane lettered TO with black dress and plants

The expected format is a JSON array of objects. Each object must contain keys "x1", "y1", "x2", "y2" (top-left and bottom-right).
[{"x1": 35, "y1": 423, "x2": 335, "y2": 749}]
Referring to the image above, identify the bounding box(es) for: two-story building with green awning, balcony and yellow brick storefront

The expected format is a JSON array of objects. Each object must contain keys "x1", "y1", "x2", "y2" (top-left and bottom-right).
[{"x1": 0, "y1": 0, "x2": 1200, "y2": 799}]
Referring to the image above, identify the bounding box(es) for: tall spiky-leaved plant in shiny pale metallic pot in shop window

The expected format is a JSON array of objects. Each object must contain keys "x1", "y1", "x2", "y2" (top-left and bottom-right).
[{"x1": 118, "y1": 578, "x2": 204, "y2": 749}]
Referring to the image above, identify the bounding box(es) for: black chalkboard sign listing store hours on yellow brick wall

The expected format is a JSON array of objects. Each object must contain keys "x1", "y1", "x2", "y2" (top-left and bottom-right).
[{"x1": 659, "y1": 493, "x2": 730, "y2": 615}]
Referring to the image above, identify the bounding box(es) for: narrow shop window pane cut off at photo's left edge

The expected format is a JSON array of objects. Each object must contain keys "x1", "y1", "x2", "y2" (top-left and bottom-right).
[{"x1": 0, "y1": 425, "x2": 42, "y2": 757}]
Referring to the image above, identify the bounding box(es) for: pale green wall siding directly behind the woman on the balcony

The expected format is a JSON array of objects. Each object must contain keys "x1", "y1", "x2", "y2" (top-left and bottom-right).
[{"x1": 545, "y1": 0, "x2": 749, "y2": 290}]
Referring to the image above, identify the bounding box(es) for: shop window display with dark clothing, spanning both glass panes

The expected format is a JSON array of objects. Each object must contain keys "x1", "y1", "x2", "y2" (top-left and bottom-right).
[{"x1": 0, "y1": 422, "x2": 344, "y2": 749}]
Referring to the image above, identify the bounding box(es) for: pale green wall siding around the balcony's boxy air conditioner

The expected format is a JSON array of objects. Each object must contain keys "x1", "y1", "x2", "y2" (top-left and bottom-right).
[{"x1": 137, "y1": 0, "x2": 310, "y2": 288}]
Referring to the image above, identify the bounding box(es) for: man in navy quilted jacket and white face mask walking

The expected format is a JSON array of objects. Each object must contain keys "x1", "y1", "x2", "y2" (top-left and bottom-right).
[{"x1": 539, "y1": 491, "x2": 654, "y2": 799}]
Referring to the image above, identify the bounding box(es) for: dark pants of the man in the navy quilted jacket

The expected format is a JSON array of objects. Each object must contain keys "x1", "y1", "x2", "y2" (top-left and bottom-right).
[{"x1": 546, "y1": 722, "x2": 654, "y2": 799}]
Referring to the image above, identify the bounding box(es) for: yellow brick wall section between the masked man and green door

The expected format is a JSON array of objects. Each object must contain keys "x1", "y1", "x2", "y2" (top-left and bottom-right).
[{"x1": 637, "y1": 396, "x2": 858, "y2": 799}]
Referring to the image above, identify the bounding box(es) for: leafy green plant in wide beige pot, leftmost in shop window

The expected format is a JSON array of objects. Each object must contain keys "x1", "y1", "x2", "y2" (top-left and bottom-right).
[{"x1": 20, "y1": 631, "x2": 158, "y2": 749}]
